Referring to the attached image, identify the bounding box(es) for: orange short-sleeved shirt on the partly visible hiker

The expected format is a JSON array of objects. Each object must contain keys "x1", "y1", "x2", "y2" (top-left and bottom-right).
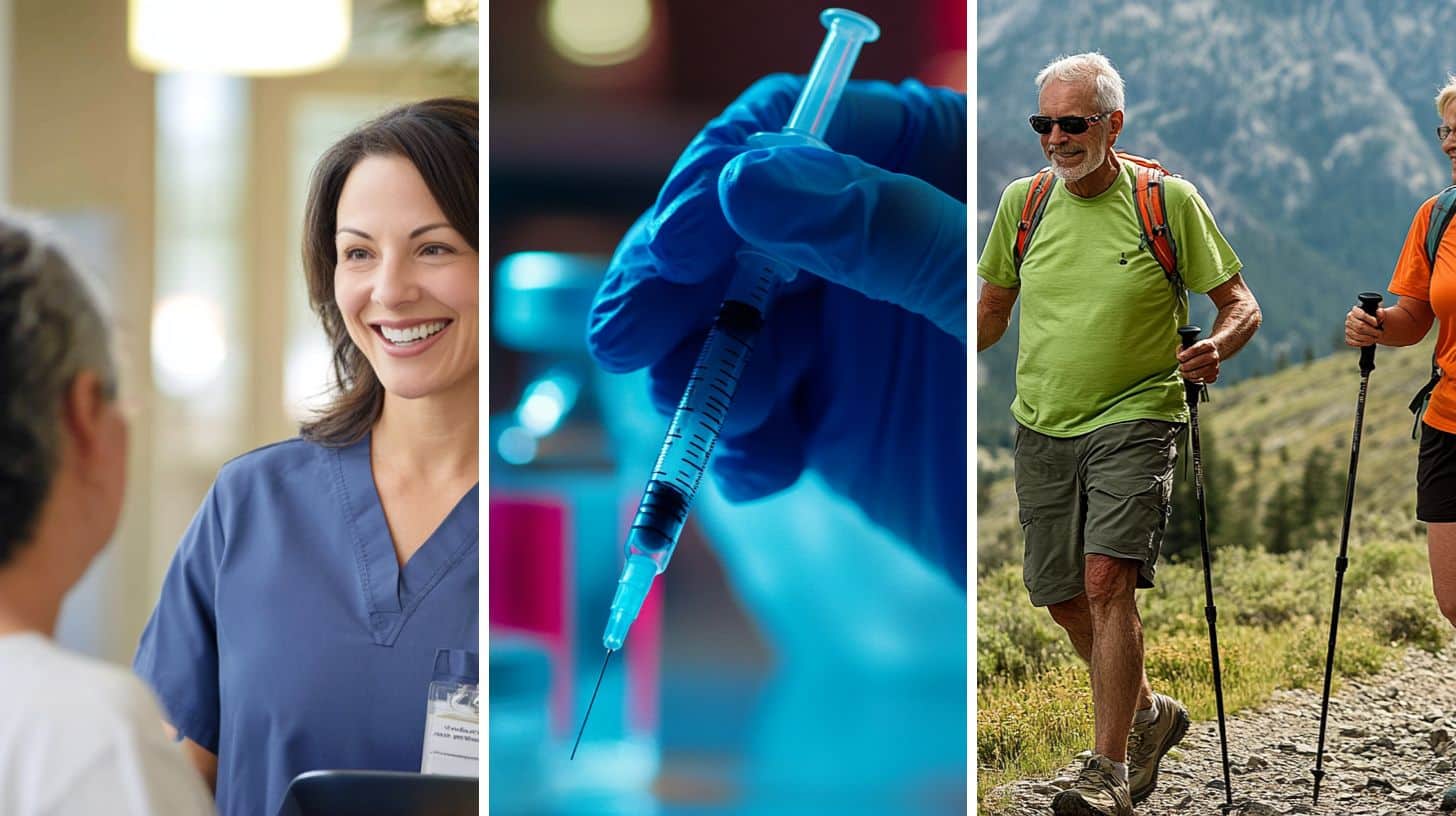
[{"x1": 1389, "y1": 195, "x2": 1456, "y2": 433}]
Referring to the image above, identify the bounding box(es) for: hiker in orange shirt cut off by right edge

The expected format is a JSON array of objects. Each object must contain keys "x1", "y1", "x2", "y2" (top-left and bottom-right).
[{"x1": 1344, "y1": 74, "x2": 1456, "y2": 812}]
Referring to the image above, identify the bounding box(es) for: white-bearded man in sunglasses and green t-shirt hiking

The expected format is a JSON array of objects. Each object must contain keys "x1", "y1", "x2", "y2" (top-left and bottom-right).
[{"x1": 976, "y1": 52, "x2": 1259, "y2": 816}]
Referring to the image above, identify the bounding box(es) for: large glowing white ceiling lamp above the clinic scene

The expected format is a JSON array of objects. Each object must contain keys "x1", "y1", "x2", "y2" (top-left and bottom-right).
[{"x1": 127, "y1": 0, "x2": 351, "y2": 76}]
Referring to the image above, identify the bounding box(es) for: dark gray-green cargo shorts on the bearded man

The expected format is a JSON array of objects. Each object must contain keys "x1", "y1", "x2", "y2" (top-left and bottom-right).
[{"x1": 1015, "y1": 420, "x2": 1184, "y2": 606}]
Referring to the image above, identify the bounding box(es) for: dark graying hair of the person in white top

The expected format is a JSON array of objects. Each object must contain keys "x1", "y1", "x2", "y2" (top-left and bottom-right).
[{"x1": 0, "y1": 213, "x2": 118, "y2": 567}]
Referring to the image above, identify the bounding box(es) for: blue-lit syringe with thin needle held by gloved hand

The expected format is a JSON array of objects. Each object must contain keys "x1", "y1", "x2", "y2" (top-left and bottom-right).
[{"x1": 572, "y1": 9, "x2": 879, "y2": 756}]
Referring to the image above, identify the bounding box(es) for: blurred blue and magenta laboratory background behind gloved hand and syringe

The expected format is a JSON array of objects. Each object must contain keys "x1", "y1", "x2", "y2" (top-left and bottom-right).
[{"x1": 488, "y1": 0, "x2": 967, "y2": 815}]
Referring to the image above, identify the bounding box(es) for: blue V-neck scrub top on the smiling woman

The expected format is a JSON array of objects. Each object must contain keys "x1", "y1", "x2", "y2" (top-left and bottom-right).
[{"x1": 134, "y1": 437, "x2": 480, "y2": 816}]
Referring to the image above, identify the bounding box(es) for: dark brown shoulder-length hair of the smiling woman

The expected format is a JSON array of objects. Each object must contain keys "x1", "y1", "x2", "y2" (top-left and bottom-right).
[{"x1": 298, "y1": 99, "x2": 480, "y2": 447}]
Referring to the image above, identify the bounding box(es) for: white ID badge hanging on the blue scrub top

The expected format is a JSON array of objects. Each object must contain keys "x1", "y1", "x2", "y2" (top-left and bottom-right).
[{"x1": 419, "y1": 648, "x2": 480, "y2": 778}]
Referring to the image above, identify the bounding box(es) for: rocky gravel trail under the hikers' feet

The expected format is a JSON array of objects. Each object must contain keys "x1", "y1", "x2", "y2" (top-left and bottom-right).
[{"x1": 986, "y1": 648, "x2": 1456, "y2": 816}]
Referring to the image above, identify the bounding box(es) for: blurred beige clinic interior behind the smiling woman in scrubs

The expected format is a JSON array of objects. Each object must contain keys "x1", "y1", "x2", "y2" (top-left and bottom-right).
[{"x1": 12, "y1": 0, "x2": 480, "y2": 666}]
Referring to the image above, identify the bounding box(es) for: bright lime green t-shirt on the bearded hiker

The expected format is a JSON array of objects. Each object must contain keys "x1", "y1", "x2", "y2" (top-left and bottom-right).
[{"x1": 976, "y1": 162, "x2": 1243, "y2": 437}]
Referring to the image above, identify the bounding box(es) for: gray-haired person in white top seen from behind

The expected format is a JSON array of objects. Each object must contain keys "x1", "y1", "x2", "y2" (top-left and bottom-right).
[{"x1": 0, "y1": 214, "x2": 213, "y2": 816}]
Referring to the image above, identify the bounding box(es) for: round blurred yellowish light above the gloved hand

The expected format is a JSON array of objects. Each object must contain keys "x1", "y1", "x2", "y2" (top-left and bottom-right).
[{"x1": 545, "y1": 0, "x2": 652, "y2": 66}]
